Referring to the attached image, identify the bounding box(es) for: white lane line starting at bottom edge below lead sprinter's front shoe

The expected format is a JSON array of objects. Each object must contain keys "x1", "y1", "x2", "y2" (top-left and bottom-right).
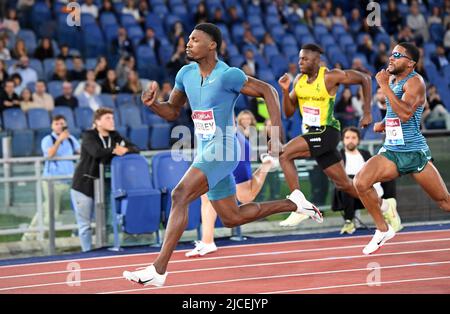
[{"x1": 100, "y1": 261, "x2": 450, "y2": 294}]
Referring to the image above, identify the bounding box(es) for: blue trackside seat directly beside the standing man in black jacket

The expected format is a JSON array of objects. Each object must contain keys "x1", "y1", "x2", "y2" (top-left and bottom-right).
[{"x1": 111, "y1": 154, "x2": 161, "y2": 249}]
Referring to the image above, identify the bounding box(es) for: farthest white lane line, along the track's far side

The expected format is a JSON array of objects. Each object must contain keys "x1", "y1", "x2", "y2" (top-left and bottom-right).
[{"x1": 0, "y1": 229, "x2": 449, "y2": 269}]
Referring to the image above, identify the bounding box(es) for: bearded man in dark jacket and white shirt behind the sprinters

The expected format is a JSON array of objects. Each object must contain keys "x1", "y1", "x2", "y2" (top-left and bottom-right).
[{"x1": 331, "y1": 127, "x2": 403, "y2": 234}]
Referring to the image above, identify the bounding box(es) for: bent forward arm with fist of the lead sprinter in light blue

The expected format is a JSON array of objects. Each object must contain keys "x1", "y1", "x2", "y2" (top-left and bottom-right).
[{"x1": 141, "y1": 82, "x2": 187, "y2": 121}]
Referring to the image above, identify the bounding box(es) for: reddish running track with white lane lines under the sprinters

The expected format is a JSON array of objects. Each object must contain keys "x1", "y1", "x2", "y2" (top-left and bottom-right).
[{"x1": 0, "y1": 225, "x2": 450, "y2": 294}]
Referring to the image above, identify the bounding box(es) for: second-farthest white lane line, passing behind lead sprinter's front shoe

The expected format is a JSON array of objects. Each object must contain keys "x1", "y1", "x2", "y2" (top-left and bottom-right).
[{"x1": 0, "y1": 248, "x2": 450, "y2": 291}]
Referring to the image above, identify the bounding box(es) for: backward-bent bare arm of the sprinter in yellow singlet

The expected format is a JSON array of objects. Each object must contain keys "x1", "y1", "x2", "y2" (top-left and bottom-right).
[{"x1": 325, "y1": 69, "x2": 372, "y2": 128}]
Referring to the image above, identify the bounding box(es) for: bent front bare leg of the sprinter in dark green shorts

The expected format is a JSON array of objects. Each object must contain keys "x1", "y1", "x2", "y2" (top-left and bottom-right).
[{"x1": 353, "y1": 155, "x2": 399, "y2": 232}]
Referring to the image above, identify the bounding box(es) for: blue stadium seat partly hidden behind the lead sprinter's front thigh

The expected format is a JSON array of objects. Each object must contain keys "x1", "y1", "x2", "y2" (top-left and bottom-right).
[{"x1": 152, "y1": 152, "x2": 201, "y2": 238}]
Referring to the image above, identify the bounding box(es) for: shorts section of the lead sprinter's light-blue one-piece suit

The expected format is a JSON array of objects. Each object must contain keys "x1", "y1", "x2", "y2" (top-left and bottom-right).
[{"x1": 192, "y1": 137, "x2": 240, "y2": 201}]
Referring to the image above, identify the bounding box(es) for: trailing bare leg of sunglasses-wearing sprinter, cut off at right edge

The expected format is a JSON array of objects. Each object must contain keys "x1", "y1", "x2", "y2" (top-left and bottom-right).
[{"x1": 412, "y1": 161, "x2": 450, "y2": 211}]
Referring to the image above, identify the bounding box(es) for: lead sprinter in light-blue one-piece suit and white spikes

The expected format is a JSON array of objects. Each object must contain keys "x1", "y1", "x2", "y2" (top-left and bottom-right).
[{"x1": 123, "y1": 23, "x2": 315, "y2": 286}]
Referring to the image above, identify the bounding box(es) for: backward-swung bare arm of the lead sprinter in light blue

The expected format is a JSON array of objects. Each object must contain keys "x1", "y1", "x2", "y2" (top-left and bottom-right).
[{"x1": 240, "y1": 76, "x2": 284, "y2": 143}]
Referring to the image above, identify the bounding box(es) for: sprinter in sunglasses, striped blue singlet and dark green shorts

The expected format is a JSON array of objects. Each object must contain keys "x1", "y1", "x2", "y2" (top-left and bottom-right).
[{"x1": 353, "y1": 42, "x2": 450, "y2": 254}]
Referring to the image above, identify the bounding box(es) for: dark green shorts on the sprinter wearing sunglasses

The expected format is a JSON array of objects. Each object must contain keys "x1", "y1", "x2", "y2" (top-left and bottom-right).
[{"x1": 378, "y1": 147, "x2": 431, "y2": 176}]
